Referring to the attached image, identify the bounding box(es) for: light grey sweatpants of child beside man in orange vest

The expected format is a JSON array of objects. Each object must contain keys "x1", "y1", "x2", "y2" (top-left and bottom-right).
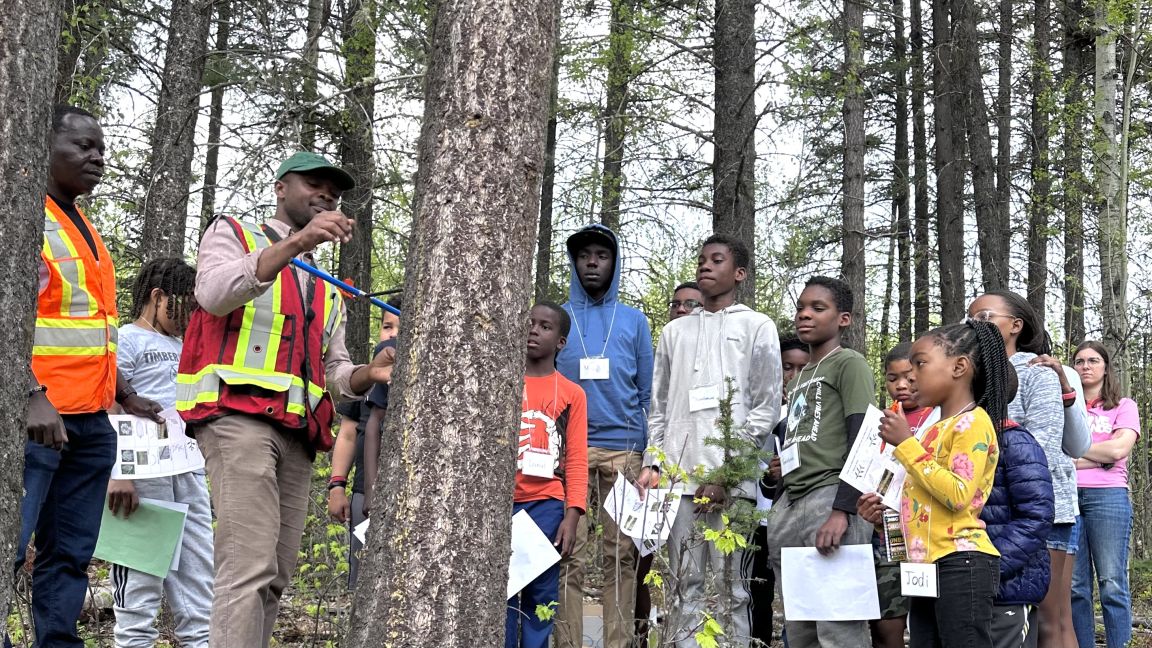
[{"x1": 112, "y1": 473, "x2": 212, "y2": 648}]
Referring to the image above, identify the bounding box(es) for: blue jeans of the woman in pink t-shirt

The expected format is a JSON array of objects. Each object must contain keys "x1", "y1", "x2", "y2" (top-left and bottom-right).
[{"x1": 1073, "y1": 488, "x2": 1132, "y2": 648}]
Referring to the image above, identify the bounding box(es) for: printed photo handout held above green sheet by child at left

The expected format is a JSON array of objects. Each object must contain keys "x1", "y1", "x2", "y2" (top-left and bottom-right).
[{"x1": 108, "y1": 408, "x2": 204, "y2": 480}]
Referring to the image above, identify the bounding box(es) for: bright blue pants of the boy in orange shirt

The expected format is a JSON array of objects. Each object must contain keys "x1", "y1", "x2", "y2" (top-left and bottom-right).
[{"x1": 505, "y1": 499, "x2": 564, "y2": 648}]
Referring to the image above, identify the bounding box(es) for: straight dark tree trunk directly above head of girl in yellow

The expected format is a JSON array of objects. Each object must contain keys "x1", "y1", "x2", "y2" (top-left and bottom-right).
[{"x1": 932, "y1": 0, "x2": 965, "y2": 322}]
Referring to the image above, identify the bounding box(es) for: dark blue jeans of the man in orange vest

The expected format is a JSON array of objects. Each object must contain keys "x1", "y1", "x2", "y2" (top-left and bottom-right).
[{"x1": 14, "y1": 412, "x2": 116, "y2": 648}]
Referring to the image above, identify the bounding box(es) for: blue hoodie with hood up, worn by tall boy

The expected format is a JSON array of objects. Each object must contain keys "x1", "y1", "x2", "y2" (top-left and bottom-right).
[{"x1": 556, "y1": 225, "x2": 653, "y2": 452}]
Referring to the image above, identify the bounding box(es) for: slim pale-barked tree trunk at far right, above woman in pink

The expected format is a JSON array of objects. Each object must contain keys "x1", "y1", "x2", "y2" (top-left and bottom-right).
[{"x1": 1092, "y1": 0, "x2": 1128, "y2": 382}]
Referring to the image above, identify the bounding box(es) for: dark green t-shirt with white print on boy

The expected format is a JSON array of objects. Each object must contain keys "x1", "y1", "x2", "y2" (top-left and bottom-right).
[{"x1": 782, "y1": 348, "x2": 876, "y2": 499}]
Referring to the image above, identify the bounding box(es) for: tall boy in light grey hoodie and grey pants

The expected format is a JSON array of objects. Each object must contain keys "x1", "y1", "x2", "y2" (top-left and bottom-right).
[{"x1": 637, "y1": 234, "x2": 781, "y2": 648}]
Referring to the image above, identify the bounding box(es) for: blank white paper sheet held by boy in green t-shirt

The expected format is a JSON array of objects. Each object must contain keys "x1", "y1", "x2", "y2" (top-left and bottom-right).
[{"x1": 780, "y1": 544, "x2": 880, "y2": 621}]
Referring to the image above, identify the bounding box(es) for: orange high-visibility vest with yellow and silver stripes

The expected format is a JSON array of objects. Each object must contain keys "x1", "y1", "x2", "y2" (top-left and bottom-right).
[{"x1": 32, "y1": 196, "x2": 119, "y2": 414}]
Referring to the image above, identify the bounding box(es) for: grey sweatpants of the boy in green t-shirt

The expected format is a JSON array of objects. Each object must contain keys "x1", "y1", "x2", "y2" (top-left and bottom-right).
[{"x1": 767, "y1": 485, "x2": 872, "y2": 648}]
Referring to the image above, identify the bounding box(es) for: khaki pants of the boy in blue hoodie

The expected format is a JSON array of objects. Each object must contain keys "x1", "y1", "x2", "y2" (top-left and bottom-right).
[{"x1": 555, "y1": 447, "x2": 643, "y2": 648}]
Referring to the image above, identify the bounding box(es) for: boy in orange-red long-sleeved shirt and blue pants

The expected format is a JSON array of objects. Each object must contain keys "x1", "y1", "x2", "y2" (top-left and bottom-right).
[{"x1": 505, "y1": 302, "x2": 588, "y2": 648}]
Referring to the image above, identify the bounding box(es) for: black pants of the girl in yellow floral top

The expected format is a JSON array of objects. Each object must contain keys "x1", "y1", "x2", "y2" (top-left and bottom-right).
[{"x1": 908, "y1": 551, "x2": 1000, "y2": 648}]
